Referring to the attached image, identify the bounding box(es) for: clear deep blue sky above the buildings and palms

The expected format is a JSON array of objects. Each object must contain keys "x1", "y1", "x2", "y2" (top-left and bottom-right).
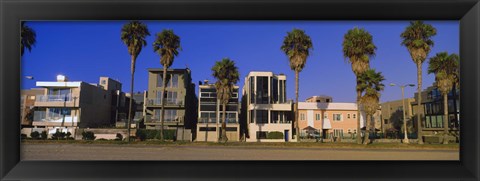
[{"x1": 21, "y1": 21, "x2": 460, "y2": 102}]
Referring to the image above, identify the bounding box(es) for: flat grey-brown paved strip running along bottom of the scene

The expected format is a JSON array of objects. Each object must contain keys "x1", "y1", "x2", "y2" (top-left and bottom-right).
[{"x1": 21, "y1": 144, "x2": 459, "y2": 160}]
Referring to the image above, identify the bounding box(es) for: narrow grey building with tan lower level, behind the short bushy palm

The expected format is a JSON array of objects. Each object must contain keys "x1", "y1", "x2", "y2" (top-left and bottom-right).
[{"x1": 196, "y1": 81, "x2": 240, "y2": 142}]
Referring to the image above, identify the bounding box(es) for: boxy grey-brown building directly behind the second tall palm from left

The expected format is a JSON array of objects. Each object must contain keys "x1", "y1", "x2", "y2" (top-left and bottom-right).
[{"x1": 144, "y1": 68, "x2": 198, "y2": 141}]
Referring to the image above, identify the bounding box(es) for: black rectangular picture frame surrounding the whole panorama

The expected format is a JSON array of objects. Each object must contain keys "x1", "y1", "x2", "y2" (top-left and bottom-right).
[{"x1": 0, "y1": 0, "x2": 480, "y2": 181}]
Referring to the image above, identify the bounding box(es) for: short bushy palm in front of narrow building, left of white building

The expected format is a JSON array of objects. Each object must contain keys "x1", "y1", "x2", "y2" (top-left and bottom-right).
[{"x1": 212, "y1": 58, "x2": 240, "y2": 142}]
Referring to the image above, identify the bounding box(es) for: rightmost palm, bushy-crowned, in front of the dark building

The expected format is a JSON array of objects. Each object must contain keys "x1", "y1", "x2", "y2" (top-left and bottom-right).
[{"x1": 428, "y1": 52, "x2": 460, "y2": 144}]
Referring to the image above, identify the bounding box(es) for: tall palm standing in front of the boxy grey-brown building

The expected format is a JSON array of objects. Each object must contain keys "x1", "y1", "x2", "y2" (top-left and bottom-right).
[{"x1": 153, "y1": 30, "x2": 181, "y2": 141}]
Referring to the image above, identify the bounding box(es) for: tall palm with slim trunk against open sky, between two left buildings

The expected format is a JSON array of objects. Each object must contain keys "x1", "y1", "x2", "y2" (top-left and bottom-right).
[{"x1": 120, "y1": 21, "x2": 150, "y2": 142}]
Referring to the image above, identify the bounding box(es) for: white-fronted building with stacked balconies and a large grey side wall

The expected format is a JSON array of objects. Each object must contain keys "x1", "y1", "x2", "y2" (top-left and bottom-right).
[{"x1": 32, "y1": 75, "x2": 124, "y2": 135}]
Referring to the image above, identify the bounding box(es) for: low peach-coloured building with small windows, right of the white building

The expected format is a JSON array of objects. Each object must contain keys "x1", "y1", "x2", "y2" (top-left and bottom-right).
[{"x1": 298, "y1": 102, "x2": 365, "y2": 139}]
